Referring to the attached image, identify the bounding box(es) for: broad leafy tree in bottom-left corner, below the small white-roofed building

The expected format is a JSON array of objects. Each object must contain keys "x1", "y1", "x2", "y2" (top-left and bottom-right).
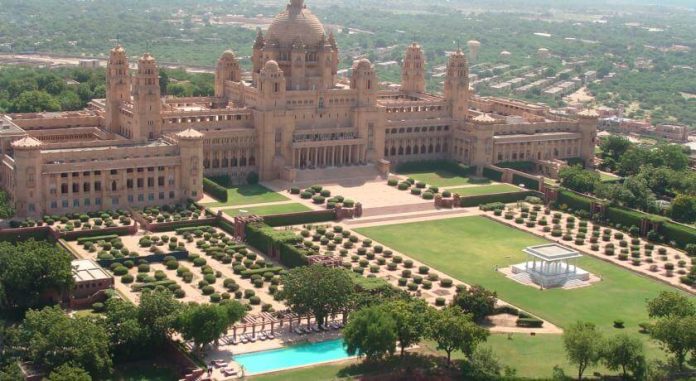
[{"x1": 20, "y1": 307, "x2": 112, "y2": 376}]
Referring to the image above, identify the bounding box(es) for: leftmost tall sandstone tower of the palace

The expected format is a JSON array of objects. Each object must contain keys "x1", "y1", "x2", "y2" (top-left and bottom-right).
[{"x1": 106, "y1": 45, "x2": 130, "y2": 133}]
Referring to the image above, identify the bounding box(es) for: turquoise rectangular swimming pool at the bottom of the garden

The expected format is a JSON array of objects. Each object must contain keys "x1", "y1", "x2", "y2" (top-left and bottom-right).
[{"x1": 234, "y1": 339, "x2": 351, "y2": 375}]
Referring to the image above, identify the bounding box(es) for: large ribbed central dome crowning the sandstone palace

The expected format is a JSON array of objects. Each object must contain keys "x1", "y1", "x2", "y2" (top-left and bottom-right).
[{"x1": 266, "y1": 0, "x2": 324, "y2": 47}]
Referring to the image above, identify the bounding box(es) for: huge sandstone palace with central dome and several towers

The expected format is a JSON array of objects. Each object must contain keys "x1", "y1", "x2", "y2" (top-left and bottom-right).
[{"x1": 0, "y1": 0, "x2": 597, "y2": 216}]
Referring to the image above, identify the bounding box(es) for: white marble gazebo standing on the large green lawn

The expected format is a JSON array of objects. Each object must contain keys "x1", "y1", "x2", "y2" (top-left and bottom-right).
[{"x1": 512, "y1": 243, "x2": 590, "y2": 288}]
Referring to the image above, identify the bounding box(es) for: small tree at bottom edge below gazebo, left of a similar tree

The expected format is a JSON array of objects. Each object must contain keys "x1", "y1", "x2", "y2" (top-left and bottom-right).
[{"x1": 563, "y1": 322, "x2": 602, "y2": 380}]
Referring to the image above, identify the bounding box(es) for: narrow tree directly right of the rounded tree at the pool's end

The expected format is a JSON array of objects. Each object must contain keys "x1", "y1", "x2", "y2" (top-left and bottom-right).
[{"x1": 385, "y1": 299, "x2": 431, "y2": 356}]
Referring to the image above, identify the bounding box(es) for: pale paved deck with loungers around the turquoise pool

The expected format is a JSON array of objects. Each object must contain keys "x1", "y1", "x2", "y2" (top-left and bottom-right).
[{"x1": 205, "y1": 324, "x2": 346, "y2": 381}]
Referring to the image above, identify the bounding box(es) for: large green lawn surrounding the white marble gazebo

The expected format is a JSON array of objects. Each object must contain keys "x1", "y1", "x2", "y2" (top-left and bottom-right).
[{"x1": 357, "y1": 217, "x2": 684, "y2": 332}]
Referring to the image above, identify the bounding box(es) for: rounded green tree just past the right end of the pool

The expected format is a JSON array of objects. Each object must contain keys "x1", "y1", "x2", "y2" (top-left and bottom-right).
[{"x1": 343, "y1": 306, "x2": 397, "y2": 360}]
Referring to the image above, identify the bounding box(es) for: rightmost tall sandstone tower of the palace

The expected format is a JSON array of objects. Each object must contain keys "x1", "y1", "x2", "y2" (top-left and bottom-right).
[{"x1": 445, "y1": 49, "x2": 469, "y2": 120}]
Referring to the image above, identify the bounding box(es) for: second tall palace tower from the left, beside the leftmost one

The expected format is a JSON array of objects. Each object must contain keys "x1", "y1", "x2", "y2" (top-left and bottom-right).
[{"x1": 129, "y1": 53, "x2": 162, "y2": 139}]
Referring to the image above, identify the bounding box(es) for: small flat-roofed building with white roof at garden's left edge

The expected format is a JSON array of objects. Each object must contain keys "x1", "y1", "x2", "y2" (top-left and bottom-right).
[{"x1": 70, "y1": 259, "x2": 114, "y2": 308}]
